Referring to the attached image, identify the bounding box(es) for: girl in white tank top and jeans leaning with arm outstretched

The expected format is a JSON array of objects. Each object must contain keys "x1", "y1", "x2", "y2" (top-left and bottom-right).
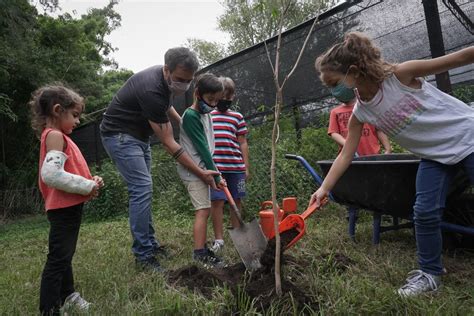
[{"x1": 310, "y1": 32, "x2": 474, "y2": 296}]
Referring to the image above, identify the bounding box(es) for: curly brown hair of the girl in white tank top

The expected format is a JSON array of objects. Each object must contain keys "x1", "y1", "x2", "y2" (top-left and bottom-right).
[{"x1": 315, "y1": 32, "x2": 395, "y2": 83}]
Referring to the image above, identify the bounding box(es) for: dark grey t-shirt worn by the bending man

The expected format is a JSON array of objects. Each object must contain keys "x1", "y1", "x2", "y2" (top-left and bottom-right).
[{"x1": 100, "y1": 66, "x2": 171, "y2": 142}]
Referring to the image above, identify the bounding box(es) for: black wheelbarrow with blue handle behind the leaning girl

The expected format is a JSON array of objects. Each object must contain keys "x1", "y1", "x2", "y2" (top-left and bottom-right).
[{"x1": 285, "y1": 154, "x2": 474, "y2": 243}]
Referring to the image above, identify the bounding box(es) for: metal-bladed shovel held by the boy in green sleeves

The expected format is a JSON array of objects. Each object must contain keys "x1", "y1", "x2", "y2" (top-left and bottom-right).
[{"x1": 223, "y1": 187, "x2": 267, "y2": 271}]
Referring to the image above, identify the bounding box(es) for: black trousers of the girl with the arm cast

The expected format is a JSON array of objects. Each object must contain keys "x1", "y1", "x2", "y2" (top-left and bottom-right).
[{"x1": 40, "y1": 203, "x2": 83, "y2": 315}]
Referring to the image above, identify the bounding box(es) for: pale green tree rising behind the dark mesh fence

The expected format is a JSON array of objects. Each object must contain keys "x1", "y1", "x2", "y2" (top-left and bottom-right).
[{"x1": 186, "y1": 0, "x2": 337, "y2": 66}]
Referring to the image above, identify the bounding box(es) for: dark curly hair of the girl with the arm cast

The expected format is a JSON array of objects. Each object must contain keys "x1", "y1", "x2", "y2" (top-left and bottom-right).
[{"x1": 28, "y1": 83, "x2": 84, "y2": 136}]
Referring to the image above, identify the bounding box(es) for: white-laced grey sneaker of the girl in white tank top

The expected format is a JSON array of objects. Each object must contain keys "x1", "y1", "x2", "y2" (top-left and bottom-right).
[{"x1": 398, "y1": 270, "x2": 441, "y2": 297}]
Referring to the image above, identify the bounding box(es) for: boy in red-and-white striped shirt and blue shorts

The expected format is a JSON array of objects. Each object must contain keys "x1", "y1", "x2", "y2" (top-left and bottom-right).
[{"x1": 211, "y1": 77, "x2": 249, "y2": 252}]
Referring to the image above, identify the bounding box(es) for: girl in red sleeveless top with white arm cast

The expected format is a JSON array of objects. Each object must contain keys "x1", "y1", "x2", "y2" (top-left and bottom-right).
[{"x1": 29, "y1": 85, "x2": 104, "y2": 315}]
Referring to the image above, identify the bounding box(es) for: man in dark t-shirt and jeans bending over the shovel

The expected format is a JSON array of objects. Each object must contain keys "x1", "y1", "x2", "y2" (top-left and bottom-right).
[{"x1": 100, "y1": 47, "x2": 217, "y2": 271}]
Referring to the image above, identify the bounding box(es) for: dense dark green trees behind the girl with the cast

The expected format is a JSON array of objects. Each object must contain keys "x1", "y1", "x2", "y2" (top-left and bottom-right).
[{"x1": 0, "y1": 0, "x2": 130, "y2": 189}]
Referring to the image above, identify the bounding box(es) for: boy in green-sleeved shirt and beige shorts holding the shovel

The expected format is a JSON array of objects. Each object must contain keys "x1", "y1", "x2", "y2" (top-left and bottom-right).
[{"x1": 178, "y1": 73, "x2": 225, "y2": 267}]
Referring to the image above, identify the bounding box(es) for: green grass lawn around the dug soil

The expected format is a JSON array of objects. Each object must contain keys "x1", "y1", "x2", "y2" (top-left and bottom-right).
[{"x1": 0, "y1": 206, "x2": 474, "y2": 315}]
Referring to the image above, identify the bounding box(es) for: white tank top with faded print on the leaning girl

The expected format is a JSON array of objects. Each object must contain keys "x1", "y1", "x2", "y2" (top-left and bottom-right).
[{"x1": 353, "y1": 75, "x2": 474, "y2": 165}]
